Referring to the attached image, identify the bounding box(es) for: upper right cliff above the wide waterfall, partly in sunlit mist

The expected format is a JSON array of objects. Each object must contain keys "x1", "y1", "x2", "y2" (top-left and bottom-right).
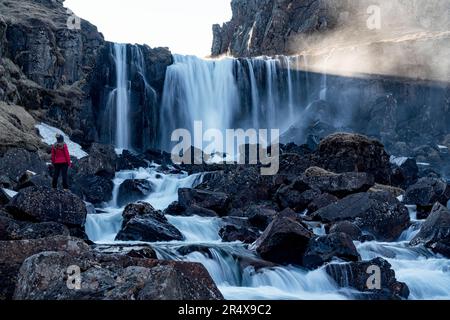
[{"x1": 212, "y1": 0, "x2": 450, "y2": 56}]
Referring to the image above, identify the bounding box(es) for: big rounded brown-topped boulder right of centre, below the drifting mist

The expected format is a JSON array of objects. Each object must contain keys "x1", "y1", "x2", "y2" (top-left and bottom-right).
[{"x1": 317, "y1": 133, "x2": 390, "y2": 184}]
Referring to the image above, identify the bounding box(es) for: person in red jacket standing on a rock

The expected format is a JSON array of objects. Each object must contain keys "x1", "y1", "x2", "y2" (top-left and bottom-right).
[{"x1": 52, "y1": 134, "x2": 72, "y2": 190}]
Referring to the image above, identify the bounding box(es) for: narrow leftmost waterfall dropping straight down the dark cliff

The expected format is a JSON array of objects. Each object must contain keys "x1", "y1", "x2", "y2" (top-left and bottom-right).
[{"x1": 109, "y1": 43, "x2": 130, "y2": 149}]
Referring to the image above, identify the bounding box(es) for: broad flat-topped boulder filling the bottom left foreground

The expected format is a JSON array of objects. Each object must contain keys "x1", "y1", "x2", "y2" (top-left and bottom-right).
[{"x1": 14, "y1": 252, "x2": 223, "y2": 300}]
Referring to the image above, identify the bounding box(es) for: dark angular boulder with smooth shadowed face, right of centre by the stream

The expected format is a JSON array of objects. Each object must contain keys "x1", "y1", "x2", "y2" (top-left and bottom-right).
[{"x1": 255, "y1": 217, "x2": 314, "y2": 265}]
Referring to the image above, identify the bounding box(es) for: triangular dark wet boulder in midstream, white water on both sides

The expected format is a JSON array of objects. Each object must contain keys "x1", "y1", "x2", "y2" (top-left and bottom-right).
[{"x1": 116, "y1": 202, "x2": 184, "y2": 242}]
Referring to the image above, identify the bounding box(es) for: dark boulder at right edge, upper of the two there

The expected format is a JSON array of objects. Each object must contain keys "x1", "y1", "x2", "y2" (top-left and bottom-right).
[{"x1": 404, "y1": 178, "x2": 450, "y2": 218}]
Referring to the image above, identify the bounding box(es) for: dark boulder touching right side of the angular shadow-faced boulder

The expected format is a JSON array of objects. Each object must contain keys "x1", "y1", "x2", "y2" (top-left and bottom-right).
[{"x1": 303, "y1": 233, "x2": 360, "y2": 269}]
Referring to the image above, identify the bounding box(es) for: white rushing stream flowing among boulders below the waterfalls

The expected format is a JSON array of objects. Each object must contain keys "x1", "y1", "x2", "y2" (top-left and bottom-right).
[{"x1": 86, "y1": 165, "x2": 450, "y2": 300}]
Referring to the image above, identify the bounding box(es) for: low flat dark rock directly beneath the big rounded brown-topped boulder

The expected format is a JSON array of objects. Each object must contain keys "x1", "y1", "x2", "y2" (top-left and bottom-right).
[{"x1": 304, "y1": 167, "x2": 375, "y2": 198}]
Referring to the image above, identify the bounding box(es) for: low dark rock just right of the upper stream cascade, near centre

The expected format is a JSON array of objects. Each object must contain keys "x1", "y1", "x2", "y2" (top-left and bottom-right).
[{"x1": 178, "y1": 188, "x2": 230, "y2": 215}]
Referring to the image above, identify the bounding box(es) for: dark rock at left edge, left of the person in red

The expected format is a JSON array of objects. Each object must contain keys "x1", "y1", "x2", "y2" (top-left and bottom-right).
[{"x1": 0, "y1": 148, "x2": 47, "y2": 181}]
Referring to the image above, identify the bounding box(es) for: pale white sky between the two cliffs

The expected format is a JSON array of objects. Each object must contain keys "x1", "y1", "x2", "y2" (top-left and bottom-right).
[{"x1": 64, "y1": 0, "x2": 231, "y2": 57}]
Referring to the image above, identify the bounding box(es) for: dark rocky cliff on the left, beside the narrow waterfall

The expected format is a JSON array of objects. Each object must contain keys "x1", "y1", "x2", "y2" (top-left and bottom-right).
[{"x1": 0, "y1": 0, "x2": 172, "y2": 151}]
